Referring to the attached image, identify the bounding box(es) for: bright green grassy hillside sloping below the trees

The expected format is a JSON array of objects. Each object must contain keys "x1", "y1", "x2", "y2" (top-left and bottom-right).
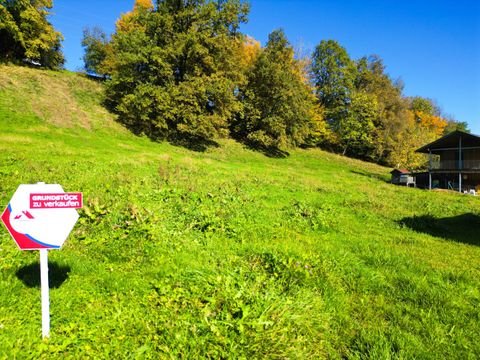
[{"x1": 0, "y1": 66, "x2": 480, "y2": 359}]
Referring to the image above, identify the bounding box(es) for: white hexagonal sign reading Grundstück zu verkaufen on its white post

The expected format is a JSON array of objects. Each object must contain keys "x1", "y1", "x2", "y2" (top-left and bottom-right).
[{"x1": 1, "y1": 183, "x2": 83, "y2": 338}]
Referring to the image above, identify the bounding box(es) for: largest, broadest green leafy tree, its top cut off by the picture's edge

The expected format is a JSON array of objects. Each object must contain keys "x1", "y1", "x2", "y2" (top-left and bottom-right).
[{"x1": 102, "y1": 0, "x2": 248, "y2": 140}]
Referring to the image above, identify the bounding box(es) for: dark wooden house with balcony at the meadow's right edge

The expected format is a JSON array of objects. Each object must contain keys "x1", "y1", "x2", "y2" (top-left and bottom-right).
[{"x1": 417, "y1": 130, "x2": 480, "y2": 192}]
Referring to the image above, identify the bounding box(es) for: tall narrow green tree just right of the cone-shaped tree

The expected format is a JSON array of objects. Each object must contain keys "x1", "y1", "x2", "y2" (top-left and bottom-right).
[{"x1": 312, "y1": 40, "x2": 356, "y2": 133}]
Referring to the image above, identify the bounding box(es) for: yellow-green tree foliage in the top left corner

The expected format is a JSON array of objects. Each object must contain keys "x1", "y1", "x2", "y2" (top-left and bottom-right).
[{"x1": 0, "y1": 0, "x2": 64, "y2": 69}]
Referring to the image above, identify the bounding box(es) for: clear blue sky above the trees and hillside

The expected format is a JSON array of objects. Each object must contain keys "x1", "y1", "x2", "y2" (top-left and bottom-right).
[{"x1": 50, "y1": 0, "x2": 480, "y2": 134}]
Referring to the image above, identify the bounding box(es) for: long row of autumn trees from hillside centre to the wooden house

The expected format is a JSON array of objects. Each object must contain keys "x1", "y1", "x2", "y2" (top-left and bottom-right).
[{"x1": 79, "y1": 0, "x2": 467, "y2": 169}]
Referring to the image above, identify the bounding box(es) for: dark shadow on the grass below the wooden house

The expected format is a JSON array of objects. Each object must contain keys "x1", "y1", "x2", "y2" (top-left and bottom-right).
[{"x1": 399, "y1": 213, "x2": 480, "y2": 246}]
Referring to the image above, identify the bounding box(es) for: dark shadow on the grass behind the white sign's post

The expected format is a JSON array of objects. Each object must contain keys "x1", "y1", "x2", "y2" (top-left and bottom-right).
[{"x1": 15, "y1": 262, "x2": 71, "y2": 289}]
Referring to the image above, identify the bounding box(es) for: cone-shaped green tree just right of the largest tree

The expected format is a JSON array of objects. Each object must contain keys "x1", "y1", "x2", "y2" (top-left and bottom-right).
[{"x1": 233, "y1": 30, "x2": 326, "y2": 150}]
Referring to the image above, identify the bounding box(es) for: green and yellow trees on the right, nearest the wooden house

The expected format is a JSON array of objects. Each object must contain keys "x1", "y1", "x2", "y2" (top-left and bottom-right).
[{"x1": 312, "y1": 47, "x2": 461, "y2": 169}]
